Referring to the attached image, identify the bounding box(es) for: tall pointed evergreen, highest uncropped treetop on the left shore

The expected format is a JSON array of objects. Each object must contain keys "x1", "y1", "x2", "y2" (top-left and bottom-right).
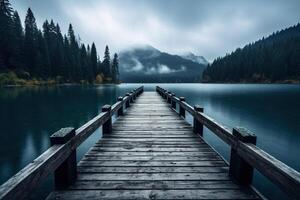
[{"x1": 24, "y1": 8, "x2": 38, "y2": 75}]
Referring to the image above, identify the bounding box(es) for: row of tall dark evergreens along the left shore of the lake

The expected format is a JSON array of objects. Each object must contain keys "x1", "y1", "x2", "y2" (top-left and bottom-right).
[{"x1": 0, "y1": 0, "x2": 119, "y2": 83}]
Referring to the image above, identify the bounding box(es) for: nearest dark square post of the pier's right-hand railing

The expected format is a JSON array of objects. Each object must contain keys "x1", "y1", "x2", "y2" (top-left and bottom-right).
[{"x1": 229, "y1": 127, "x2": 256, "y2": 185}]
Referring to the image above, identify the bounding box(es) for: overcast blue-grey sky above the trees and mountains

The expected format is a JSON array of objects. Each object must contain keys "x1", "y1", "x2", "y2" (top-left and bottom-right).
[{"x1": 11, "y1": 0, "x2": 300, "y2": 61}]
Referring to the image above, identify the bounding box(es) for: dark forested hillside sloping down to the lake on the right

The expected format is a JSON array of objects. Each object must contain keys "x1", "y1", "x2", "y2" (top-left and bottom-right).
[{"x1": 203, "y1": 24, "x2": 300, "y2": 82}]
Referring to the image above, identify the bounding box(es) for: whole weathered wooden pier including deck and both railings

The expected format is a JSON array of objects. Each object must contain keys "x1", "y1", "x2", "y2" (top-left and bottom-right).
[{"x1": 0, "y1": 87, "x2": 300, "y2": 200}]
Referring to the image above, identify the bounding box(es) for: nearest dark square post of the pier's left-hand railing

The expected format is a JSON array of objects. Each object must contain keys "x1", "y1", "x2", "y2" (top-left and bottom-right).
[{"x1": 50, "y1": 127, "x2": 77, "y2": 190}]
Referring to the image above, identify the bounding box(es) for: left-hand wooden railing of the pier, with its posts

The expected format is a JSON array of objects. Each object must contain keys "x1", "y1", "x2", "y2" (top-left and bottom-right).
[{"x1": 0, "y1": 86, "x2": 144, "y2": 200}]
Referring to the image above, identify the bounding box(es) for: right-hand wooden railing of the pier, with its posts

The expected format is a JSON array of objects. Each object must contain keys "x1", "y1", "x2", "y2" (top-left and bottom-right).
[{"x1": 156, "y1": 86, "x2": 300, "y2": 199}]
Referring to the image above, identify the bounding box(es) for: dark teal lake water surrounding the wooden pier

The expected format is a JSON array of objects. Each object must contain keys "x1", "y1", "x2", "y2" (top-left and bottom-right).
[{"x1": 0, "y1": 84, "x2": 300, "y2": 199}]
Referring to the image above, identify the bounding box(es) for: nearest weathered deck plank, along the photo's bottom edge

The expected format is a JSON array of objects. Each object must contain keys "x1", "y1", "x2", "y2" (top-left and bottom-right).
[{"x1": 47, "y1": 188, "x2": 259, "y2": 200}]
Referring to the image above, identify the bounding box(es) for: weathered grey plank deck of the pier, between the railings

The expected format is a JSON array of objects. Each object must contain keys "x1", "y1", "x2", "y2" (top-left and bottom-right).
[{"x1": 48, "y1": 92, "x2": 260, "y2": 200}]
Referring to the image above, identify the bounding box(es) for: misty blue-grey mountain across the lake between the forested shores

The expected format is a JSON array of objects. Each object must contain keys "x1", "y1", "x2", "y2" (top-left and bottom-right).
[{"x1": 119, "y1": 45, "x2": 206, "y2": 83}]
